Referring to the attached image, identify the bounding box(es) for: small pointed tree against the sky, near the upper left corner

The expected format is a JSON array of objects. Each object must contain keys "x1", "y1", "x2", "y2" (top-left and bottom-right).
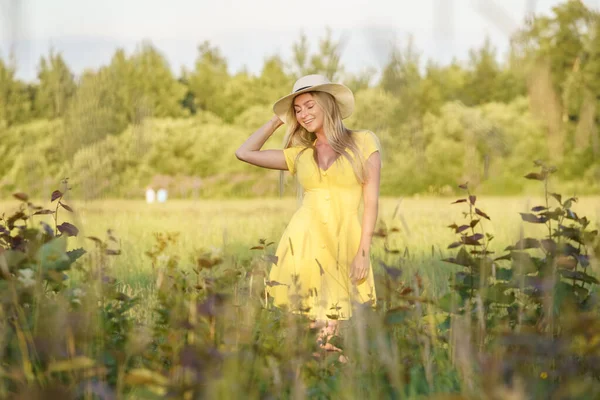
[{"x1": 34, "y1": 50, "x2": 76, "y2": 119}]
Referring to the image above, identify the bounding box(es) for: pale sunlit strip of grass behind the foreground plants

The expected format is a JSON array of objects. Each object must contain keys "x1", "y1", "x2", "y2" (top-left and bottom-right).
[{"x1": 0, "y1": 197, "x2": 600, "y2": 302}]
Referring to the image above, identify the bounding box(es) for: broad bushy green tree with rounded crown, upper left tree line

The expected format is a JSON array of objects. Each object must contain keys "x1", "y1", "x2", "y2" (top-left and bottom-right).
[{"x1": 64, "y1": 43, "x2": 185, "y2": 157}]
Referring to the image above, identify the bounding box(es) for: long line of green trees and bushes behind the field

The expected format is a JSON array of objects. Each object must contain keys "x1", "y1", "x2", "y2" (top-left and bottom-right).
[{"x1": 0, "y1": 1, "x2": 600, "y2": 198}]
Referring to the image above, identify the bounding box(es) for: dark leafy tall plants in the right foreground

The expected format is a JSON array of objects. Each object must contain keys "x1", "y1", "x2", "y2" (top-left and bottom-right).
[{"x1": 439, "y1": 161, "x2": 600, "y2": 398}]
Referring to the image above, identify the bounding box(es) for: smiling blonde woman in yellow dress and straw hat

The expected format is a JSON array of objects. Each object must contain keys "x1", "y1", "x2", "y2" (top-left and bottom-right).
[{"x1": 236, "y1": 75, "x2": 381, "y2": 344}]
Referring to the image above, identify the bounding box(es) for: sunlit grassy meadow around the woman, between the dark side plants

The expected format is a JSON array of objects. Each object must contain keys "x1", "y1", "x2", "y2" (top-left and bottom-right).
[{"x1": 0, "y1": 191, "x2": 600, "y2": 399}]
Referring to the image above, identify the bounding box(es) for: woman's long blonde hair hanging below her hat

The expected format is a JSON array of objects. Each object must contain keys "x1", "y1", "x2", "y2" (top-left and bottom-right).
[{"x1": 283, "y1": 91, "x2": 366, "y2": 185}]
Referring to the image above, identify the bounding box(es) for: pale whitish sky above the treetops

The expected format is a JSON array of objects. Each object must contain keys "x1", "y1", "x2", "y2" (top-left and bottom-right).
[{"x1": 0, "y1": 0, "x2": 600, "y2": 81}]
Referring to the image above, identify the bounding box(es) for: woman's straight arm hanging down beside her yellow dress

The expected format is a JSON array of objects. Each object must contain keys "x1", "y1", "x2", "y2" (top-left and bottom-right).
[{"x1": 350, "y1": 151, "x2": 381, "y2": 283}]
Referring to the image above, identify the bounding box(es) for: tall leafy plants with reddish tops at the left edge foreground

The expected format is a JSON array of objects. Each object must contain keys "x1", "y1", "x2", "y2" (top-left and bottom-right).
[{"x1": 0, "y1": 185, "x2": 142, "y2": 398}]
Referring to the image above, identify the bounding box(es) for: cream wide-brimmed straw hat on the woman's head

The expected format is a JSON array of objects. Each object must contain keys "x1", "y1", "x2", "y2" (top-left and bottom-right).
[{"x1": 273, "y1": 74, "x2": 354, "y2": 122}]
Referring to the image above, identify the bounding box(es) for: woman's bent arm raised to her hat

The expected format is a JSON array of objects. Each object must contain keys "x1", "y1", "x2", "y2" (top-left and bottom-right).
[{"x1": 235, "y1": 116, "x2": 288, "y2": 170}]
